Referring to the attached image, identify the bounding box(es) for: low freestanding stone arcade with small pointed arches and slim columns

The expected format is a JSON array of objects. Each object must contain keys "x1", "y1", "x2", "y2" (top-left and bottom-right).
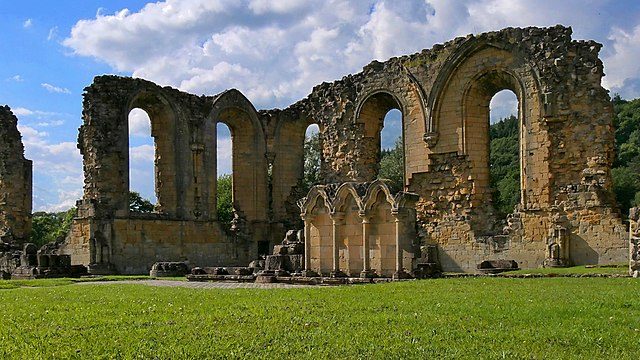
[{"x1": 300, "y1": 180, "x2": 420, "y2": 278}]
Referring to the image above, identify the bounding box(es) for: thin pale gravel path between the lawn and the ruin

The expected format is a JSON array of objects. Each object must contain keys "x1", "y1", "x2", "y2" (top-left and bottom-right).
[{"x1": 78, "y1": 280, "x2": 311, "y2": 289}]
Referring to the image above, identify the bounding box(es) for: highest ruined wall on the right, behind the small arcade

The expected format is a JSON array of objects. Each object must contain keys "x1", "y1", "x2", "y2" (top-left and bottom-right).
[{"x1": 275, "y1": 26, "x2": 627, "y2": 270}]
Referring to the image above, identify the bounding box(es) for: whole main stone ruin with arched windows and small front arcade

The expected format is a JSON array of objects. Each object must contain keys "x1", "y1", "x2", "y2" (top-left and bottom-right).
[{"x1": 0, "y1": 26, "x2": 637, "y2": 277}]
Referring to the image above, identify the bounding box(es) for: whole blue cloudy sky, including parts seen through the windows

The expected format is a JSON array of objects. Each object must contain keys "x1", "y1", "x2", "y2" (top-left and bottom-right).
[{"x1": 0, "y1": 0, "x2": 640, "y2": 210}]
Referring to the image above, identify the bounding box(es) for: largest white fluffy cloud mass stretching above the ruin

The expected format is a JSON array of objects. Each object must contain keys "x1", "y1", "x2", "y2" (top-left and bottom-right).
[{"x1": 64, "y1": 0, "x2": 637, "y2": 107}]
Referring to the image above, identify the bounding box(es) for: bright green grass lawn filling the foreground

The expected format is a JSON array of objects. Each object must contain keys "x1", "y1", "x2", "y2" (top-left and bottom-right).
[{"x1": 0, "y1": 278, "x2": 640, "y2": 359}]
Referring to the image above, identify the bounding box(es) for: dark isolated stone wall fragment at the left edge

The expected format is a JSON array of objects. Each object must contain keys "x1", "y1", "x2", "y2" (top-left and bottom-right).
[{"x1": 0, "y1": 106, "x2": 32, "y2": 244}]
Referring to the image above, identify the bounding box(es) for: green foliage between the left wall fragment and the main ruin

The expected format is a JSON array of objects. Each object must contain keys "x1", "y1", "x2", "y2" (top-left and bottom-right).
[{"x1": 30, "y1": 208, "x2": 78, "y2": 247}]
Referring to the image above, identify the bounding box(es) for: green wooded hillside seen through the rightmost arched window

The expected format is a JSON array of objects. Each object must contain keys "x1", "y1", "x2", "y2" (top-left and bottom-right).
[{"x1": 489, "y1": 115, "x2": 520, "y2": 218}]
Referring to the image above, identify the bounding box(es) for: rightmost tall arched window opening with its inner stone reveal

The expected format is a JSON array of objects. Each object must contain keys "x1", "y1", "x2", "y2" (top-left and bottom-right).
[{"x1": 463, "y1": 71, "x2": 525, "y2": 222}]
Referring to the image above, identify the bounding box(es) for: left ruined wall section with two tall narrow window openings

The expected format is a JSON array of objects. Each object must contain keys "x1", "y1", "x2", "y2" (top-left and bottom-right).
[{"x1": 62, "y1": 76, "x2": 271, "y2": 273}]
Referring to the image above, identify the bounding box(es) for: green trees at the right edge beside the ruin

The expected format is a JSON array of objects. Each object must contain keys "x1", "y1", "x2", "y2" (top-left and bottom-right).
[{"x1": 611, "y1": 95, "x2": 640, "y2": 215}]
